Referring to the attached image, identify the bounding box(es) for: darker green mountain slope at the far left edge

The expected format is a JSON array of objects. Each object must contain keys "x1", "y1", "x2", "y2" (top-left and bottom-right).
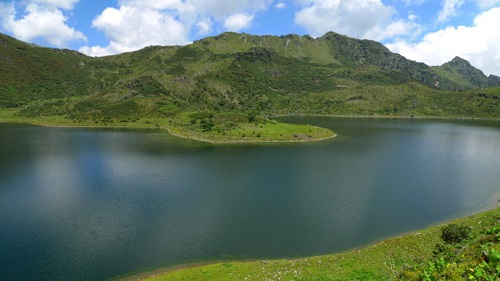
[{"x1": 0, "y1": 34, "x2": 93, "y2": 107}]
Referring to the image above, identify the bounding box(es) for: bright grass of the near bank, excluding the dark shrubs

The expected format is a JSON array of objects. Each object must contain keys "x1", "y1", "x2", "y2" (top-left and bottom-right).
[{"x1": 122, "y1": 208, "x2": 500, "y2": 281}]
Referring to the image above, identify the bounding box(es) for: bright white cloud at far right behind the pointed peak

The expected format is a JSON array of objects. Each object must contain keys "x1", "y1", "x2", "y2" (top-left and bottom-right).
[{"x1": 387, "y1": 8, "x2": 500, "y2": 75}]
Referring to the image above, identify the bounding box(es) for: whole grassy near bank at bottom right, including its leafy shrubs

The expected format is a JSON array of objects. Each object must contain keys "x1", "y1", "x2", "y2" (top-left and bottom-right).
[{"x1": 118, "y1": 208, "x2": 500, "y2": 281}]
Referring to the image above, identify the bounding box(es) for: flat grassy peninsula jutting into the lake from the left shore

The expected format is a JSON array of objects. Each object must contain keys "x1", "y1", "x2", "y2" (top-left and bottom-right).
[{"x1": 0, "y1": 109, "x2": 336, "y2": 143}]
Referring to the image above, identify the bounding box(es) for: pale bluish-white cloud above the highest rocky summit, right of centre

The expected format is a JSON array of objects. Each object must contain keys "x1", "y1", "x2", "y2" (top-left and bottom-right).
[{"x1": 295, "y1": 0, "x2": 417, "y2": 40}]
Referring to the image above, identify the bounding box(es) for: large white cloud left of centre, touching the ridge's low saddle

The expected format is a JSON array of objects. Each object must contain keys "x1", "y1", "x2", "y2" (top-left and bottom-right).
[{"x1": 80, "y1": 0, "x2": 273, "y2": 56}]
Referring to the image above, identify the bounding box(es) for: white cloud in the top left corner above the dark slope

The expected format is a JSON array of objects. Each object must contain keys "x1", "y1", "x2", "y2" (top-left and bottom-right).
[{"x1": 0, "y1": 0, "x2": 87, "y2": 47}]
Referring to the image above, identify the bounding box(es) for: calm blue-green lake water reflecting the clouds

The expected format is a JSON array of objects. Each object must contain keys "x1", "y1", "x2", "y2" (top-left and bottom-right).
[{"x1": 0, "y1": 117, "x2": 500, "y2": 280}]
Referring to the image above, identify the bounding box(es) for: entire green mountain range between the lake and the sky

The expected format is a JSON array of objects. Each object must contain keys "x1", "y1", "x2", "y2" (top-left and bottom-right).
[{"x1": 0, "y1": 32, "x2": 500, "y2": 122}]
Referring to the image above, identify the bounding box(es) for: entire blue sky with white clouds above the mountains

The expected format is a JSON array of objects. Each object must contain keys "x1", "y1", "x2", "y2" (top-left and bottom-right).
[{"x1": 0, "y1": 0, "x2": 500, "y2": 75}]
